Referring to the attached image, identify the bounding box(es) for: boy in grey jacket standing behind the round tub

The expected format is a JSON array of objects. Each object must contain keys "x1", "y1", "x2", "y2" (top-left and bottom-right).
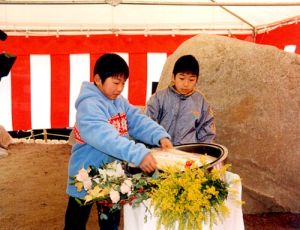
[{"x1": 146, "y1": 55, "x2": 216, "y2": 145}]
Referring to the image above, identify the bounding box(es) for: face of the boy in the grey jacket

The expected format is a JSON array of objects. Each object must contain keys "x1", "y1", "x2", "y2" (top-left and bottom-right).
[{"x1": 172, "y1": 73, "x2": 198, "y2": 95}]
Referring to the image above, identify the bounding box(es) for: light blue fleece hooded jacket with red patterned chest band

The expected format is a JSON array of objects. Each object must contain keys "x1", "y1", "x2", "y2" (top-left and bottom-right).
[{"x1": 67, "y1": 82, "x2": 170, "y2": 198}]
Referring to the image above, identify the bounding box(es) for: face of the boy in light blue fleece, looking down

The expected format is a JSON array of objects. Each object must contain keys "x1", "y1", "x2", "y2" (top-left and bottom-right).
[{"x1": 94, "y1": 75, "x2": 126, "y2": 100}]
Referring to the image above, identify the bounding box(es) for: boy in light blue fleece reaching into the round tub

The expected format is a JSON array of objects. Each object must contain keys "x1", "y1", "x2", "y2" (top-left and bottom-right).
[{"x1": 64, "y1": 53, "x2": 173, "y2": 230}]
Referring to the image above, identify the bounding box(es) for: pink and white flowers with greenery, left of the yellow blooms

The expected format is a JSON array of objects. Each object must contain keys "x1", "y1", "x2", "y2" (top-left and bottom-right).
[{"x1": 71, "y1": 161, "x2": 151, "y2": 218}]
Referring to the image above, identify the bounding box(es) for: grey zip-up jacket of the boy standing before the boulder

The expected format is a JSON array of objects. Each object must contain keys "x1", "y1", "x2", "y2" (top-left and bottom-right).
[{"x1": 146, "y1": 86, "x2": 216, "y2": 145}]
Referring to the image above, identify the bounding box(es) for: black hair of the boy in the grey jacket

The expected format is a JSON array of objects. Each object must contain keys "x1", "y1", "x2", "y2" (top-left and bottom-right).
[{"x1": 173, "y1": 55, "x2": 199, "y2": 76}]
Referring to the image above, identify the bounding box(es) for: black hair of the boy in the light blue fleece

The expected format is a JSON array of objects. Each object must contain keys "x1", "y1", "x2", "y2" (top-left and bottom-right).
[{"x1": 94, "y1": 53, "x2": 129, "y2": 82}]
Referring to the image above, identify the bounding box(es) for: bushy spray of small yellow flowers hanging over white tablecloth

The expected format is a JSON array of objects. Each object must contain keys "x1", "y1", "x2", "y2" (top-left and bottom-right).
[{"x1": 151, "y1": 161, "x2": 230, "y2": 230}]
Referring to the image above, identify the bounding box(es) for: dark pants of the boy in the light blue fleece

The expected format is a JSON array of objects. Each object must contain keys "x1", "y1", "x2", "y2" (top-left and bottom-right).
[{"x1": 64, "y1": 197, "x2": 120, "y2": 230}]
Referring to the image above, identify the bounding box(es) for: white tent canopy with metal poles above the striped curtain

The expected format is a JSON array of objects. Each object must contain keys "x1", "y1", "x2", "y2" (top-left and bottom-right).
[{"x1": 0, "y1": 0, "x2": 300, "y2": 35}]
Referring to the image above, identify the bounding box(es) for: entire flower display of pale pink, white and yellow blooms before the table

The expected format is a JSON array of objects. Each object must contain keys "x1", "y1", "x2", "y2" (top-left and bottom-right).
[{"x1": 71, "y1": 158, "x2": 237, "y2": 230}]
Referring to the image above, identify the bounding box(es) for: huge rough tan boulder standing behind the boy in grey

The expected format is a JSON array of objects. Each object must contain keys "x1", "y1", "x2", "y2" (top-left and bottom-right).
[{"x1": 158, "y1": 35, "x2": 300, "y2": 214}]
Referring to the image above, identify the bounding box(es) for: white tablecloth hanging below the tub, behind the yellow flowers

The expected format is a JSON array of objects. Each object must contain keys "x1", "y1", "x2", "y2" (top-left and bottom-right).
[{"x1": 124, "y1": 172, "x2": 244, "y2": 230}]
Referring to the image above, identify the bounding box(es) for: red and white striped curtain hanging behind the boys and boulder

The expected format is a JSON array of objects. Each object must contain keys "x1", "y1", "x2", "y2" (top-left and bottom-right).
[{"x1": 0, "y1": 24, "x2": 300, "y2": 131}]
